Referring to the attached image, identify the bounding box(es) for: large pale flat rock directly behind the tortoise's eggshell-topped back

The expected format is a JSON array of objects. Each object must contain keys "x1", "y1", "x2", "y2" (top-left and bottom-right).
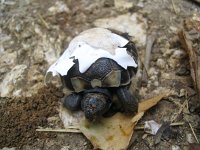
[{"x1": 94, "y1": 13, "x2": 147, "y2": 46}]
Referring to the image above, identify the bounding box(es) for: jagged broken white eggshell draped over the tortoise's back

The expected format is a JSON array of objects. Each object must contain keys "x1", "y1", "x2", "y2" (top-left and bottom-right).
[{"x1": 47, "y1": 28, "x2": 137, "y2": 76}]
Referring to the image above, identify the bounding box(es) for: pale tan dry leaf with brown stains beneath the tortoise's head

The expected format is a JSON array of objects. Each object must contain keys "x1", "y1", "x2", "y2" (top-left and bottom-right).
[{"x1": 80, "y1": 113, "x2": 134, "y2": 150}]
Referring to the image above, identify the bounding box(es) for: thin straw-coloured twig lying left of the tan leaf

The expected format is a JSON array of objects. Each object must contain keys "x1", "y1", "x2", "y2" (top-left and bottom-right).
[{"x1": 36, "y1": 128, "x2": 81, "y2": 133}]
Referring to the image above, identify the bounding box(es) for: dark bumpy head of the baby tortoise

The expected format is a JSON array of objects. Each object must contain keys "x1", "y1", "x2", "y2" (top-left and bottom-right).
[{"x1": 81, "y1": 93, "x2": 111, "y2": 121}]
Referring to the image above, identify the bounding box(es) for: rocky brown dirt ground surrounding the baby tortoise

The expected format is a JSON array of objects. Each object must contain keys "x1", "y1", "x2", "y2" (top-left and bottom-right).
[{"x1": 0, "y1": 0, "x2": 200, "y2": 150}]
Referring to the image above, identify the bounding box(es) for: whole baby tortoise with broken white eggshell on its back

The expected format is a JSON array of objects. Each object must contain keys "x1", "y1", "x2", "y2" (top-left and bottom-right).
[{"x1": 48, "y1": 28, "x2": 138, "y2": 121}]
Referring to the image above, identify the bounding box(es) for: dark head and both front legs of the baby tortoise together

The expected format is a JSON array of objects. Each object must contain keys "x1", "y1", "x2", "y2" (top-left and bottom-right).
[{"x1": 64, "y1": 86, "x2": 138, "y2": 121}]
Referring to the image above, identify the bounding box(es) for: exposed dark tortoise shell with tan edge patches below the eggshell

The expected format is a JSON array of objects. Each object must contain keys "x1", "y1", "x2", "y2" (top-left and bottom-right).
[{"x1": 61, "y1": 58, "x2": 137, "y2": 92}]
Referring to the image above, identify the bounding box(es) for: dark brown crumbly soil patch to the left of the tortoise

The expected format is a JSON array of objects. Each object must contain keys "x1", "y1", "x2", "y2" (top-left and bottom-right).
[{"x1": 0, "y1": 86, "x2": 59, "y2": 148}]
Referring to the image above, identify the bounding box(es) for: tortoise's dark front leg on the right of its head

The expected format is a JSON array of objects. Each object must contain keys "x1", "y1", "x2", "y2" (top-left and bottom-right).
[{"x1": 117, "y1": 86, "x2": 138, "y2": 114}]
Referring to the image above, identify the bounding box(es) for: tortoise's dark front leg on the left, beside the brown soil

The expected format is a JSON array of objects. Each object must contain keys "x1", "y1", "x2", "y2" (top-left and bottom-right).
[{"x1": 63, "y1": 93, "x2": 82, "y2": 111}]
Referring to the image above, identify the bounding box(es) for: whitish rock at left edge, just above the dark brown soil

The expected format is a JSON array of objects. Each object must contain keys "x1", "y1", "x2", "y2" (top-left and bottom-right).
[{"x1": 0, "y1": 65, "x2": 27, "y2": 97}]
